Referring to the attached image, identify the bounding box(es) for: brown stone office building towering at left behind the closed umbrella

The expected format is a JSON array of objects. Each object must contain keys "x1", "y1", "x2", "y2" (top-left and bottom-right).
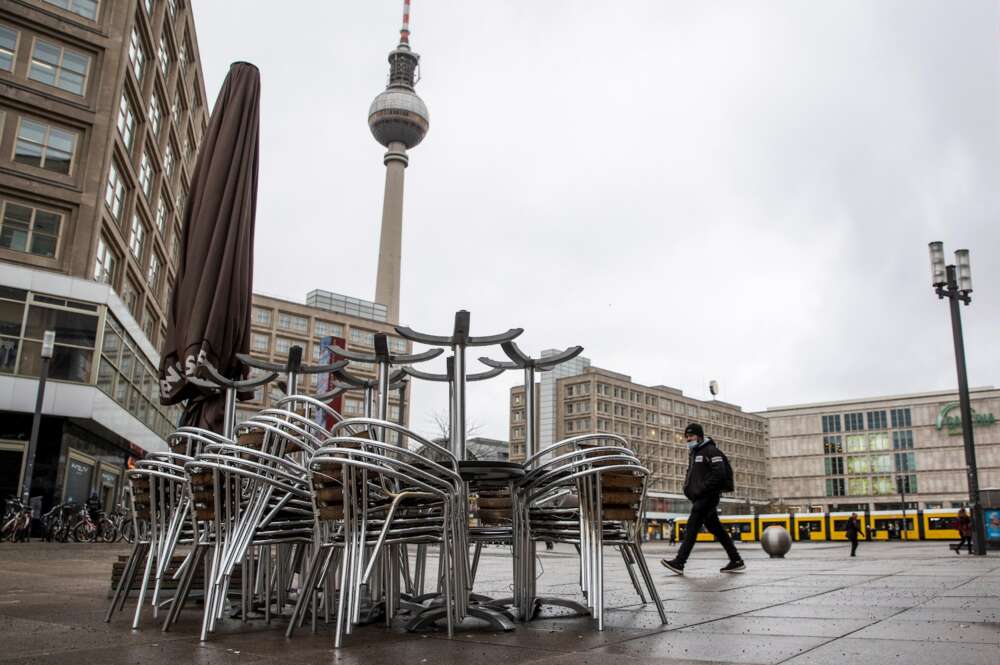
[{"x1": 0, "y1": 0, "x2": 208, "y2": 508}]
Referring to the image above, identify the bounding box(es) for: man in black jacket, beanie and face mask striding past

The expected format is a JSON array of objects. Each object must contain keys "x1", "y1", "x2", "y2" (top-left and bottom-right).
[{"x1": 660, "y1": 423, "x2": 746, "y2": 575}]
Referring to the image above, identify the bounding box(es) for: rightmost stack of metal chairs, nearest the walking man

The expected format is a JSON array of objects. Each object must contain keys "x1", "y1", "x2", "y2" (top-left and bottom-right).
[{"x1": 514, "y1": 434, "x2": 667, "y2": 630}]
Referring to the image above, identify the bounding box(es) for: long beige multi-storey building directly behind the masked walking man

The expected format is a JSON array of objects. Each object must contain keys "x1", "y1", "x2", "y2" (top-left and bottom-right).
[{"x1": 510, "y1": 353, "x2": 768, "y2": 513}]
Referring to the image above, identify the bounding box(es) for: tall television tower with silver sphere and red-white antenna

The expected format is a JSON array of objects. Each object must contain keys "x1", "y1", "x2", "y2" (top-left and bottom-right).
[{"x1": 368, "y1": 0, "x2": 430, "y2": 323}]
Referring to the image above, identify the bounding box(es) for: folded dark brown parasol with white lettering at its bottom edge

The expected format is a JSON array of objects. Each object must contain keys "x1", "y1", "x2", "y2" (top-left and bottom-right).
[{"x1": 160, "y1": 62, "x2": 260, "y2": 432}]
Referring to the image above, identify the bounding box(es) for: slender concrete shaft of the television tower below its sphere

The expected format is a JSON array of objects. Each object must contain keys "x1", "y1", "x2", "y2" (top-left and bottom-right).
[{"x1": 375, "y1": 141, "x2": 409, "y2": 323}]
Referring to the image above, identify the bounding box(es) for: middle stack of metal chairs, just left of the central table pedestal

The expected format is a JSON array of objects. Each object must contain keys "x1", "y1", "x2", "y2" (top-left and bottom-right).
[{"x1": 296, "y1": 418, "x2": 469, "y2": 647}]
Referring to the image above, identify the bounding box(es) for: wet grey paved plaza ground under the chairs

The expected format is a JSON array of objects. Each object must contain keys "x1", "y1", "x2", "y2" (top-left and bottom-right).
[{"x1": 0, "y1": 543, "x2": 1000, "y2": 665}]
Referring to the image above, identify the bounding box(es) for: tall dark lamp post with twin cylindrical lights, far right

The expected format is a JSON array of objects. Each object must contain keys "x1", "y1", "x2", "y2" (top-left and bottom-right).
[{"x1": 930, "y1": 242, "x2": 986, "y2": 555}]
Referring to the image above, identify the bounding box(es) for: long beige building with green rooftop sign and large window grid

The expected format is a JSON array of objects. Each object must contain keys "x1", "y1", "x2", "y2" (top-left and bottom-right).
[{"x1": 760, "y1": 388, "x2": 1000, "y2": 511}]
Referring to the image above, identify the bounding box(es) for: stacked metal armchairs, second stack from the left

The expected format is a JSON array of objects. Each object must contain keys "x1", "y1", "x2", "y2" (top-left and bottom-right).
[{"x1": 164, "y1": 395, "x2": 340, "y2": 640}]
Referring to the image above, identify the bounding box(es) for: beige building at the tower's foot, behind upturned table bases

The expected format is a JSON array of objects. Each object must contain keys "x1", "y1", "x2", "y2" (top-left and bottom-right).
[{"x1": 237, "y1": 290, "x2": 412, "y2": 430}]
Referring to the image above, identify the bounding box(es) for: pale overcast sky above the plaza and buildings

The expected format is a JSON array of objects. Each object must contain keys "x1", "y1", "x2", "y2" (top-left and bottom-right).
[{"x1": 194, "y1": 0, "x2": 1000, "y2": 439}]
